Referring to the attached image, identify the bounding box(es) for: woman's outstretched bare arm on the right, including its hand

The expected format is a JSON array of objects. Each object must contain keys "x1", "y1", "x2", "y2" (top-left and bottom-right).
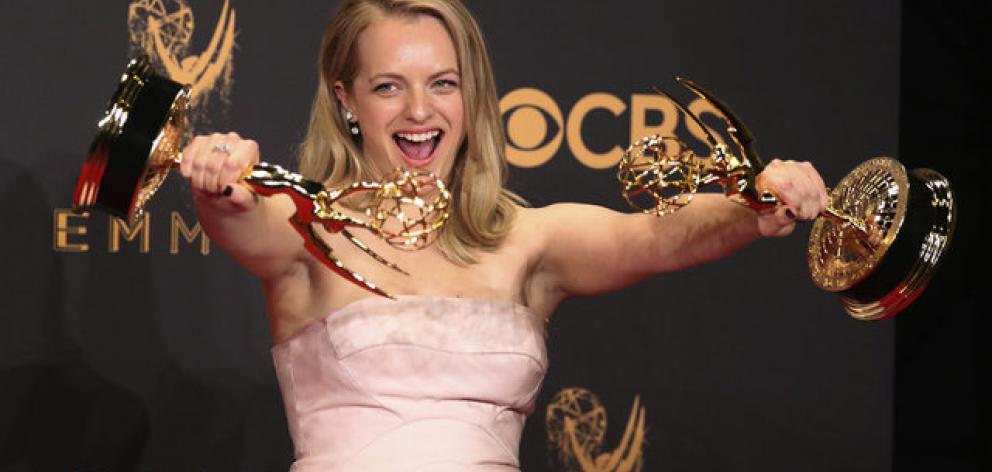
[{"x1": 531, "y1": 160, "x2": 827, "y2": 297}]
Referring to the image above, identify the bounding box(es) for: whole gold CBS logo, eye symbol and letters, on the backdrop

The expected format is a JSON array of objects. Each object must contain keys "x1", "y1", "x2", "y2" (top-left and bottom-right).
[{"x1": 499, "y1": 88, "x2": 720, "y2": 169}]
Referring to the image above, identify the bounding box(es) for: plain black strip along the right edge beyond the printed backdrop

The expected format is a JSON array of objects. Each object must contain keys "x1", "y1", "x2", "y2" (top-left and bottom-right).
[{"x1": 893, "y1": 1, "x2": 992, "y2": 471}]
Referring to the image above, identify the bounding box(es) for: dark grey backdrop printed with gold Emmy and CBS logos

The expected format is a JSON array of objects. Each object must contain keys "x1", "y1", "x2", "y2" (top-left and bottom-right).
[{"x1": 0, "y1": 0, "x2": 899, "y2": 471}]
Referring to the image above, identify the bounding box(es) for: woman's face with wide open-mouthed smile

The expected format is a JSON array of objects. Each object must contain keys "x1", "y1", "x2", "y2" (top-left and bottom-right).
[{"x1": 334, "y1": 15, "x2": 465, "y2": 179}]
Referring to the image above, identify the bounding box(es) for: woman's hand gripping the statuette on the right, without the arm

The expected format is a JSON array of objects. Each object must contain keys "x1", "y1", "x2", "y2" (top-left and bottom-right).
[{"x1": 755, "y1": 159, "x2": 828, "y2": 237}]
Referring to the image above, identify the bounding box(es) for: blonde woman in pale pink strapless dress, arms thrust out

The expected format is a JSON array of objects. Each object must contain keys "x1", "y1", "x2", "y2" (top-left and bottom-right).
[{"x1": 181, "y1": 0, "x2": 826, "y2": 471}]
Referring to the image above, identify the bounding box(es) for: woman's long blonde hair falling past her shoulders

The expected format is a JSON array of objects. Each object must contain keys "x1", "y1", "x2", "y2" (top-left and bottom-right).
[{"x1": 300, "y1": 0, "x2": 525, "y2": 264}]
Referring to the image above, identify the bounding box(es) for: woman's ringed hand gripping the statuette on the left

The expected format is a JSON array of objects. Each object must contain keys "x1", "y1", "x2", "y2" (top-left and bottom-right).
[{"x1": 179, "y1": 133, "x2": 259, "y2": 212}]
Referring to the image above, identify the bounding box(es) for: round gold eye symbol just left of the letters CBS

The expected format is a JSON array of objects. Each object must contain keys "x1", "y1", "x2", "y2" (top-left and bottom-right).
[{"x1": 499, "y1": 88, "x2": 565, "y2": 167}]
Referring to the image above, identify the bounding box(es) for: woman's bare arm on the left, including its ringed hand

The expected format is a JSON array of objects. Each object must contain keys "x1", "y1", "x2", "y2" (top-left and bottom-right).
[{"x1": 180, "y1": 133, "x2": 303, "y2": 280}]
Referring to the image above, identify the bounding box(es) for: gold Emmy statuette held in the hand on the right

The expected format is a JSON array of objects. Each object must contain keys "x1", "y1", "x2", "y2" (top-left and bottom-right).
[{"x1": 617, "y1": 78, "x2": 956, "y2": 320}]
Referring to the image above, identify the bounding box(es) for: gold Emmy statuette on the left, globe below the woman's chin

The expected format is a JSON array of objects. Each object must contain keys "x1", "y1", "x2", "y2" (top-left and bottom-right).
[{"x1": 73, "y1": 56, "x2": 451, "y2": 297}]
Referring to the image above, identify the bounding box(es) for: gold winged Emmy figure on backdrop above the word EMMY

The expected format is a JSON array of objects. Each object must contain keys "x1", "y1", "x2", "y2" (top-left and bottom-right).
[{"x1": 127, "y1": 0, "x2": 236, "y2": 125}]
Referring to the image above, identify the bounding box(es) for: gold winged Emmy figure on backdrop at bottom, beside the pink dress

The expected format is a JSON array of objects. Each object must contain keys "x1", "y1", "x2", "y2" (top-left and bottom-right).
[{"x1": 545, "y1": 387, "x2": 645, "y2": 472}]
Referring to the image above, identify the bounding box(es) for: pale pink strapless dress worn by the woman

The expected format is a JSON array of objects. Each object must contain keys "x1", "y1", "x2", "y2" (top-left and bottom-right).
[{"x1": 272, "y1": 296, "x2": 547, "y2": 472}]
